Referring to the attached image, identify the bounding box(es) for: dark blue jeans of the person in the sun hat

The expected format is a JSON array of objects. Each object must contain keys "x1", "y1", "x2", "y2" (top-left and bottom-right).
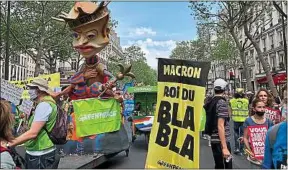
[{"x1": 25, "y1": 150, "x2": 60, "y2": 169}]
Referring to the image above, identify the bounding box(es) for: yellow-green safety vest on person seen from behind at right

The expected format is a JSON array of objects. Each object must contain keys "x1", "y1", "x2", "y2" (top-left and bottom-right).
[{"x1": 230, "y1": 98, "x2": 249, "y2": 122}]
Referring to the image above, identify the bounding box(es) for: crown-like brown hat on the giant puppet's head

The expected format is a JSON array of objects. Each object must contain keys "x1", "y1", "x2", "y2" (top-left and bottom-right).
[{"x1": 53, "y1": 1, "x2": 110, "y2": 29}]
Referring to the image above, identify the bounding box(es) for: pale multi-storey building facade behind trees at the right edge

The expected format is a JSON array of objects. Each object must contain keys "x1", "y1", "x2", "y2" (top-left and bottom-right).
[{"x1": 238, "y1": 1, "x2": 287, "y2": 91}]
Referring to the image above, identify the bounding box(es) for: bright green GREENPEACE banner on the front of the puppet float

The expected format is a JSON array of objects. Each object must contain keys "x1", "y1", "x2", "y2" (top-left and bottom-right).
[{"x1": 73, "y1": 99, "x2": 121, "y2": 137}]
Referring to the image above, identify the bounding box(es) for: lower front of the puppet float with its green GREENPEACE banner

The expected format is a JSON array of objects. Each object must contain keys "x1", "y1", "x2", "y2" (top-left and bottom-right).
[{"x1": 59, "y1": 98, "x2": 129, "y2": 155}]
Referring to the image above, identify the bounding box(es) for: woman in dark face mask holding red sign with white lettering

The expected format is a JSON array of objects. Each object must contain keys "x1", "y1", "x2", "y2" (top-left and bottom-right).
[{"x1": 243, "y1": 99, "x2": 273, "y2": 169}]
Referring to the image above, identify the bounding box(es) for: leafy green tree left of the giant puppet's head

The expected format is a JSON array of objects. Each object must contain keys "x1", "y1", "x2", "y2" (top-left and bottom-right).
[{"x1": 1, "y1": 1, "x2": 73, "y2": 76}]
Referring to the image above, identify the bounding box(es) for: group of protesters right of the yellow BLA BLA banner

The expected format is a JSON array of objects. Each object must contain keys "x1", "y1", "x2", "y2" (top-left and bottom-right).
[{"x1": 202, "y1": 79, "x2": 287, "y2": 169}]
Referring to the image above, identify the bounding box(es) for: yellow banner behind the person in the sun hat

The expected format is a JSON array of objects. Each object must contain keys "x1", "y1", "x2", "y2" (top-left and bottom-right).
[{"x1": 10, "y1": 73, "x2": 60, "y2": 99}]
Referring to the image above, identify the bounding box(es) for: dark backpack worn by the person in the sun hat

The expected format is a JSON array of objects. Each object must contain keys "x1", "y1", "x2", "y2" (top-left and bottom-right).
[{"x1": 44, "y1": 100, "x2": 68, "y2": 145}]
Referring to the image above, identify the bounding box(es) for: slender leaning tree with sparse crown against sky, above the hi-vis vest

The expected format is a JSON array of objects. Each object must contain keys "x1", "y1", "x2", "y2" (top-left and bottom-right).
[{"x1": 190, "y1": 1, "x2": 252, "y2": 91}]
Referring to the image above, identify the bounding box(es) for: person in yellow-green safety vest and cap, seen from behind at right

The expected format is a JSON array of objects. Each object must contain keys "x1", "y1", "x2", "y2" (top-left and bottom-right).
[{"x1": 230, "y1": 88, "x2": 249, "y2": 155}]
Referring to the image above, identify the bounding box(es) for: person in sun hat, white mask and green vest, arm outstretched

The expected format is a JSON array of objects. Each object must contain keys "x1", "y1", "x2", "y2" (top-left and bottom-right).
[{"x1": 8, "y1": 78, "x2": 60, "y2": 169}]
